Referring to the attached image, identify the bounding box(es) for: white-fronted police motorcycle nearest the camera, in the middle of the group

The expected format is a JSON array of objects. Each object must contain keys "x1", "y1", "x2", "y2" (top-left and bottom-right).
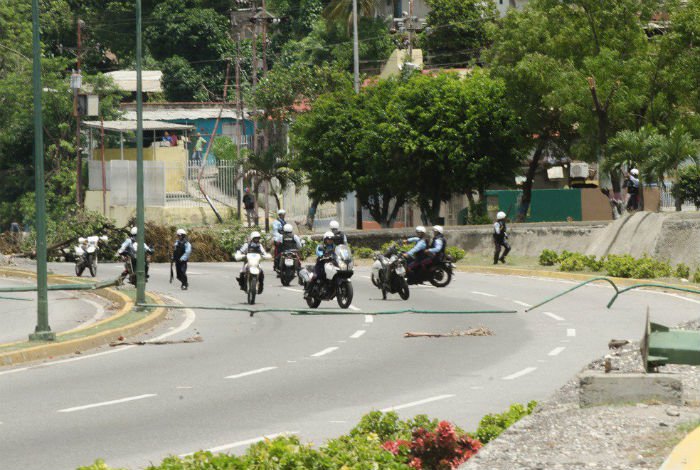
[{"x1": 299, "y1": 245, "x2": 353, "y2": 308}]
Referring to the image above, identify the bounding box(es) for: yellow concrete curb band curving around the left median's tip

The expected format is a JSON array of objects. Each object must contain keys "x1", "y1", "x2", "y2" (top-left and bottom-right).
[{"x1": 0, "y1": 268, "x2": 167, "y2": 366}]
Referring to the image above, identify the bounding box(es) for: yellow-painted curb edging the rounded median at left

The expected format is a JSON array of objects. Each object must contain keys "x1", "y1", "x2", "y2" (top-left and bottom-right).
[{"x1": 0, "y1": 268, "x2": 167, "y2": 366}]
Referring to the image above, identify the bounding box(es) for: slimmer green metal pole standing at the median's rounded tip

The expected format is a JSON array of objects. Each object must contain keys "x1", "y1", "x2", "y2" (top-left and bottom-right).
[{"x1": 136, "y1": 0, "x2": 146, "y2": 304}]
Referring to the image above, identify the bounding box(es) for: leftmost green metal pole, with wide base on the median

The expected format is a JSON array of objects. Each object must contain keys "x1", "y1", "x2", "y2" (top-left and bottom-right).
[{"x1": 29, "y1": 0, "x2": 56, "y2": 341}]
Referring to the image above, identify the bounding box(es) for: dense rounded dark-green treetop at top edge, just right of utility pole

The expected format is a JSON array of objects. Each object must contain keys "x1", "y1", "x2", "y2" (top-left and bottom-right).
[{"x1": 420, "y1": 0, "x2": 498, "y2": 67}]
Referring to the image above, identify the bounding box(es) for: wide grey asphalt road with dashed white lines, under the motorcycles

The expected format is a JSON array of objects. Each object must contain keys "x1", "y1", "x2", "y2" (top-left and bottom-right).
[{"x1": 0, "y1": 263, "x2": 700, "y2": 469}]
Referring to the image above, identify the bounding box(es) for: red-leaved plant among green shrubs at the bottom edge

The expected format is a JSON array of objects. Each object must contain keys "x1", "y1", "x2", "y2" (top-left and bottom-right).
[{"x1": 383, "y1": 421, "x2": 481, "y2": 470}]
